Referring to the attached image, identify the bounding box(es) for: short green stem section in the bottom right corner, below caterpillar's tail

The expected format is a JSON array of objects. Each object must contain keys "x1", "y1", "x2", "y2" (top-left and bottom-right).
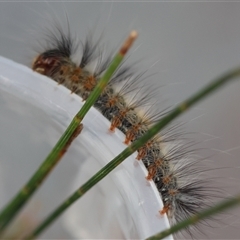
[{"x1": 147, "y1": 195, "x2": 240, "y2": 240}]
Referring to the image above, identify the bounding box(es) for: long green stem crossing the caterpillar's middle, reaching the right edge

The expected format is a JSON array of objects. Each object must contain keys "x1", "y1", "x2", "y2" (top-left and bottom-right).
[{"x1": 24, "y1": 68, "x2": 240, "y2": 239}]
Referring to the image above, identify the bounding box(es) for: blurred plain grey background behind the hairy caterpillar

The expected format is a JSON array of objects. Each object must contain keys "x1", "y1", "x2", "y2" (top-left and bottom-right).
[{"x1": 0, "y1": 1, "x2": 240, "y2": 239}]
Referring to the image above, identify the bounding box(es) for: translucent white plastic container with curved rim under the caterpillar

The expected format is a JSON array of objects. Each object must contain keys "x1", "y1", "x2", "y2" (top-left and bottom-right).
[{"x1": 0, "y1": 57, "x2": 172, "y2": 239}]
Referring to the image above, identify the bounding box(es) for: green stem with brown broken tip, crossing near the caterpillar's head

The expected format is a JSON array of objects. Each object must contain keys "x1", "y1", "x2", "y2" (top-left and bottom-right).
[{"x1": 0, "y1": 31, "x2": 137, "y2": 233}]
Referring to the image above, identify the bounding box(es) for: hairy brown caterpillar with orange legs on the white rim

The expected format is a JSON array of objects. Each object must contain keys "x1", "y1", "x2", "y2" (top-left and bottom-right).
[{"x1": 32, "y1": 23, "x2": 215, "y2": 238}]
